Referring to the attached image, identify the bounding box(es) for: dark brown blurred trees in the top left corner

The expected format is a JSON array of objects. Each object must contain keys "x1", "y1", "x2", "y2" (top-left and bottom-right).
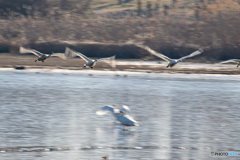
[{"x1": 0, "y1": 0, "x2": 92, "y2": 19}]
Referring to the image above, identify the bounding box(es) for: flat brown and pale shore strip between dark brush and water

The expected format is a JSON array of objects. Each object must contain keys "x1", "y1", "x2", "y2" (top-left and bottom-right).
[{"x1": 0, "y1": 54, "x2": 240, "y2": 75}]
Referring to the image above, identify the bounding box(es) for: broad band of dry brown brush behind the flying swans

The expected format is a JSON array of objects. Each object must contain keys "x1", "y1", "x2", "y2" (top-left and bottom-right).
[{"x1": 0, "y1": 0, "x2": 240, "y2": 61}]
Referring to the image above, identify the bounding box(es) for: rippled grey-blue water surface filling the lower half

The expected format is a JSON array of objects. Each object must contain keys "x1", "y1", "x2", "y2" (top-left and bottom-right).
[{"x1": 0, "y1": 71, "x2": 240, "y2": 160}]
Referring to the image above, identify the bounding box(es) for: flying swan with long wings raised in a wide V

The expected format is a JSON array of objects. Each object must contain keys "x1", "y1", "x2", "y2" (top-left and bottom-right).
[{"x1": 138, "y1": 45, "x2": 203, "y2": 68}]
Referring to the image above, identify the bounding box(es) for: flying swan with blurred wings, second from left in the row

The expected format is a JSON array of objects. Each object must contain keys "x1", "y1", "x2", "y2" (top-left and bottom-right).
[{"x1": 65, "y1": 47, "x2": 116, "y2": 68}]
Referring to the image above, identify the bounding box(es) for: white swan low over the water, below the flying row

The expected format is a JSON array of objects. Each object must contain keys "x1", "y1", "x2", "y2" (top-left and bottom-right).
[{"x1": 96, "y1": 105, "x2": 139, "y2": 126}]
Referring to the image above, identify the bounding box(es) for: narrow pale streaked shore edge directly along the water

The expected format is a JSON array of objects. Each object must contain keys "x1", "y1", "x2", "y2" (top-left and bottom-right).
[{"x1": 0, "y1": 61, "x2": 240, "y2": 75}]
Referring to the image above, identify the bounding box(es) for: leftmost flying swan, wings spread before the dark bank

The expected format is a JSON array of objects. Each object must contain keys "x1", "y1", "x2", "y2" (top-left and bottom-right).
[{"x1": 19, "y1": 46, "x2": 66, "y2": 62}]
